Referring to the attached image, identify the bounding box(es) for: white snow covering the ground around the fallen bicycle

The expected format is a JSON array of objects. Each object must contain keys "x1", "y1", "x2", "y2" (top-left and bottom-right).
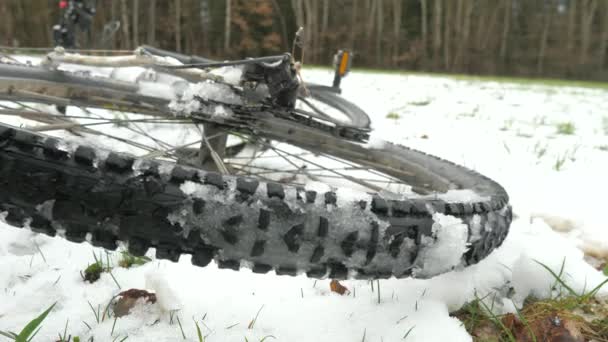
[{"x1": 0, "y1": 70, "x2": 608, "y2": 342}]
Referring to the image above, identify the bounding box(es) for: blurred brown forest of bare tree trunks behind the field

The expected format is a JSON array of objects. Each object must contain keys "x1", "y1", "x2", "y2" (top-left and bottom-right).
[{"x1": 0, "y1": 0, "x2": 608, "y2": 81}]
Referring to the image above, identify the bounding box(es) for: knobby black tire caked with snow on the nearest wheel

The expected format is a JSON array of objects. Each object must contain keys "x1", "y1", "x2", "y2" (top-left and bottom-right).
[{"x1": 0, "y1": 124, "x2": 512, "y2": 279}]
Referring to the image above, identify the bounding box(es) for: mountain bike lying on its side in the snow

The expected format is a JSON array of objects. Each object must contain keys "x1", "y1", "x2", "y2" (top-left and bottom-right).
[{"x1": 0, "y1": 47, "x2": 512, "y2": 279}]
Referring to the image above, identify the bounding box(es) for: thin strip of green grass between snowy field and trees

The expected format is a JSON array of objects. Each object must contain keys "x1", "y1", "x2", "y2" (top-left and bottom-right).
[{"x1": 303, "y1": 62, "x2": 608, "y2": 90}]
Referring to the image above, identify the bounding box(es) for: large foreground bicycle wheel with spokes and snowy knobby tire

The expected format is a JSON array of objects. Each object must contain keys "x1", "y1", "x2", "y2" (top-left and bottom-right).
[{"x1": 0, "y1": 57, "x2": 511, "y2": 279}]
